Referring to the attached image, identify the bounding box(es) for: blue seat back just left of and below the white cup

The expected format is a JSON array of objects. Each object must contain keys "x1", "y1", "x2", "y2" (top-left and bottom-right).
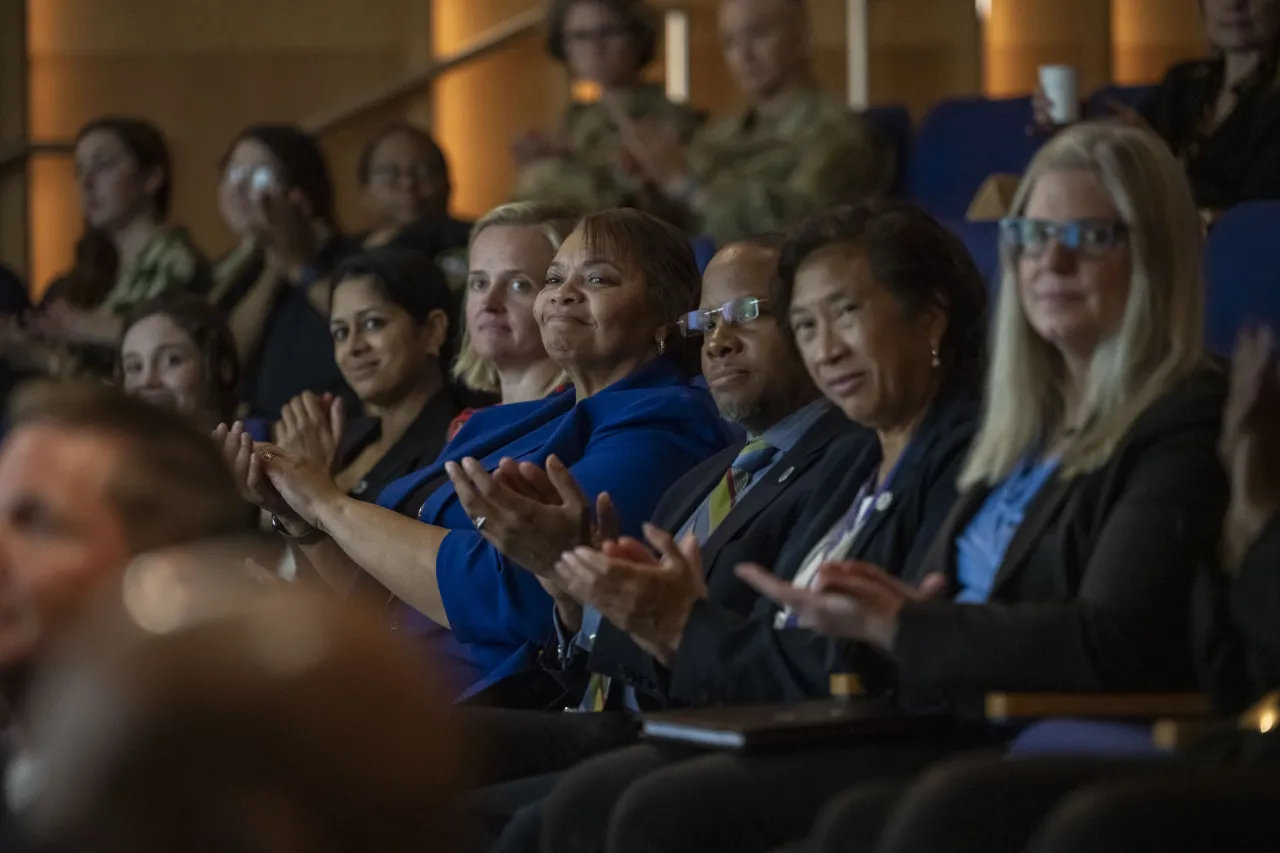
[{"x1": 904, "y1": 97, "x2": 1043, "y2": 219}]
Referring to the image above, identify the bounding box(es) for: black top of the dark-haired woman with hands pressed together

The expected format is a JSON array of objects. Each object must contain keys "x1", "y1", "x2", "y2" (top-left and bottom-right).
[{"x1": 334, "y1": 387, "x2": 462, "y2": 503}]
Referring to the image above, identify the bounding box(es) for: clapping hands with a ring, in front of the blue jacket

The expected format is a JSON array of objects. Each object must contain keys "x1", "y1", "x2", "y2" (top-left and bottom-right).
[{"x1": 444, "y1": 456, "x2": 614, "y2": 579}]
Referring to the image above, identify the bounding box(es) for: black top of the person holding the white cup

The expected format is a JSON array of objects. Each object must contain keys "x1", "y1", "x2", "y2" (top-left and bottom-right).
[{"x1": 1142, "y1": 59, "x2": 1280, "y2": 210}]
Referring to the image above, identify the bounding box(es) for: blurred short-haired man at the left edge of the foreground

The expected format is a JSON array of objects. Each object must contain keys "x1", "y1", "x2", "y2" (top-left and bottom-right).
[{"x1": 0, "y1": 382, "x2": 244, "y2": 849}]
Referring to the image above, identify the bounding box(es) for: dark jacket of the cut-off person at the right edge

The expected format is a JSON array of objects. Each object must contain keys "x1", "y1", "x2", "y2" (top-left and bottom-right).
[{"x1": 1194, "y1": 516, "x2": 1280, "y2": 712}]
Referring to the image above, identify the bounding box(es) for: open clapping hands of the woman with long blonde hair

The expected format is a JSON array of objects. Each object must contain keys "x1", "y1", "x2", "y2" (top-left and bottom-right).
[{"x1": 736, "y1": 561, "x2": 947, "y2": 652}]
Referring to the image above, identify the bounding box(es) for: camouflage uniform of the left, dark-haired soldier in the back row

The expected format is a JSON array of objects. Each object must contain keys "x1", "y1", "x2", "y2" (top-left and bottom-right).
[{"x1": 511, "y1": 86, "x2": 701, "y2": 211}]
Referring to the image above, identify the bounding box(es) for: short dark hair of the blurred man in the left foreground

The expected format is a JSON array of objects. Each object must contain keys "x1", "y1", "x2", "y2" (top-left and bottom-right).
[{"x1": 9, "y1": 380, "x2": 247, "y2": 553}]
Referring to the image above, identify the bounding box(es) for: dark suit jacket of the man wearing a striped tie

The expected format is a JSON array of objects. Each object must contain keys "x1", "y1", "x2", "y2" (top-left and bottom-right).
[{"x1": 547, "y1": 407, "x2": 873, "y2": 708}]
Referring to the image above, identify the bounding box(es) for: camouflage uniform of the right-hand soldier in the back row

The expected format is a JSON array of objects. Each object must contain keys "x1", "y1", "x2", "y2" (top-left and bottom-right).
[{"x1": 686, "y1": 90, "x2": 897, "y2": 245}]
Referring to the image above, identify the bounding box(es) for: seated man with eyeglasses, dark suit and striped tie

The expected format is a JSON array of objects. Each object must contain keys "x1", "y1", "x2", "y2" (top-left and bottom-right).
[{"x1": 463, "y1": 229, "x2": 858, "y2": 850}]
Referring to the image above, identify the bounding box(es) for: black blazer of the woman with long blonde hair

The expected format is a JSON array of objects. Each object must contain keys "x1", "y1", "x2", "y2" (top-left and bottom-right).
[{"x1": 893, "y1": 369, "x2": 1226, "y2": 711}]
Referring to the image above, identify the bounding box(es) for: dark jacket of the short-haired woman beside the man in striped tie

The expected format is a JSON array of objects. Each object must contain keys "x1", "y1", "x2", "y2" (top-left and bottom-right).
[{"x1": 669, "y1": 387, "x2": 979, "y2": 704}]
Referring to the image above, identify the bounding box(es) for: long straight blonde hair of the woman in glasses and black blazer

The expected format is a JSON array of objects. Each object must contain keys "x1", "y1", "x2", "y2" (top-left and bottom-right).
[{"x1": 960, "y1": 122, "x2": 1204, "y2": 488}]
